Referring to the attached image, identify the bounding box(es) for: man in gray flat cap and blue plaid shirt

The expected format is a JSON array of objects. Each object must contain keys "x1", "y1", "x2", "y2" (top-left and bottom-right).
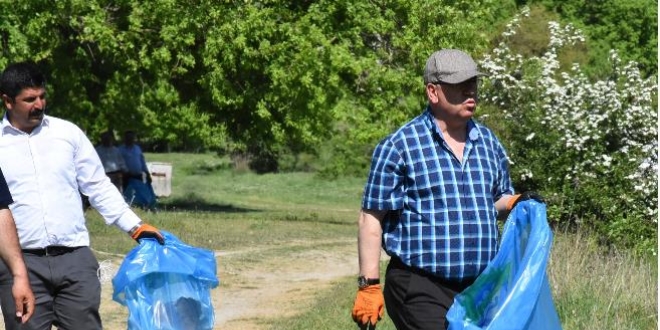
[{"x1": 352, "y1": 49, "x2": 531, "y2": 330}]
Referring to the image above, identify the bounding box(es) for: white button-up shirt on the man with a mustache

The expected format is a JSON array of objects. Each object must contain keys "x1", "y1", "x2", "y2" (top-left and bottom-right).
[{"x1": 0, "y1": 114, "x2": 140, "y2": 249}]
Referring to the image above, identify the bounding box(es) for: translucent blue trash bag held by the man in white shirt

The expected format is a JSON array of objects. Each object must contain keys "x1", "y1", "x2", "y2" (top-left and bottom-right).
[{"x1": 112, "y1": 230, "x2": 219, "y2": 330}]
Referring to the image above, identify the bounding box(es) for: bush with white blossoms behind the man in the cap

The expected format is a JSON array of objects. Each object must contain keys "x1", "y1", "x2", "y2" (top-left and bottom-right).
[{"x1": 480, "y1": 10, "x2": 658, "y2": 254}]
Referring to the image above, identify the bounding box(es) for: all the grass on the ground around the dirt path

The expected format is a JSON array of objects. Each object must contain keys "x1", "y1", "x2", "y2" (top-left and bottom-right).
[{"x1": 88, "y1": 154, "x2": 658, "y2": 330}]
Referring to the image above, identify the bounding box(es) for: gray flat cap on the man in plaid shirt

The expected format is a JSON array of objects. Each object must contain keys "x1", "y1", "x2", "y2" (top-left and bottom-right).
[{"x1": 424, "y1": 49, "x2": 485, "y2": 84}]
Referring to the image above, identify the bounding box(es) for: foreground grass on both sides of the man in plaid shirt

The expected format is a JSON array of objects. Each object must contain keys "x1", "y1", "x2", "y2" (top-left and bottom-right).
[{"x1": 270, "y1": 233, "x2": 658, "y2": 330}]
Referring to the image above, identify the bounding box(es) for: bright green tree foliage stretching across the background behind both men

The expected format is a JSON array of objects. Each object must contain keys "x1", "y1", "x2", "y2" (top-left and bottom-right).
[{"x1": 0, "y1": 0, "x2": 514, "y2": 172}]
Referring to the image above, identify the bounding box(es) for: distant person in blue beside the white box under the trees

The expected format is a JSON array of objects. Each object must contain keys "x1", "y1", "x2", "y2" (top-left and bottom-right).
[{"x1": 119, "y1": 131, "x2": 157, "y2": 211}]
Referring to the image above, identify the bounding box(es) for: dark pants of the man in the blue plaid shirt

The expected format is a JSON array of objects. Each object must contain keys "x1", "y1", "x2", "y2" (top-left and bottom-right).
[{"x1": 383, "y1": 257, "x2": 473, "y2": 330}]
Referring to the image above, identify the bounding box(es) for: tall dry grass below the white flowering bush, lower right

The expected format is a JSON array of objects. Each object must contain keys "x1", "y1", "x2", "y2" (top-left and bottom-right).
[{"x1": 549, "y1": 234, "x2": 658, "y2": 330}]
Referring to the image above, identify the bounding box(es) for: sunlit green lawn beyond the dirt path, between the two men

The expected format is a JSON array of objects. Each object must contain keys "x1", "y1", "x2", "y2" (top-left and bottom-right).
[{"x1": 87, "y1": 154, "x2": 362, "y2": 253}]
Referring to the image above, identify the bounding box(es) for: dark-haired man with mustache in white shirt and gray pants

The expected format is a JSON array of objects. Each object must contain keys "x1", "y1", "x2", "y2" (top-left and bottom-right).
[{"x1": 0, "y1": 62, "x2": 164, "y2": 330}]
